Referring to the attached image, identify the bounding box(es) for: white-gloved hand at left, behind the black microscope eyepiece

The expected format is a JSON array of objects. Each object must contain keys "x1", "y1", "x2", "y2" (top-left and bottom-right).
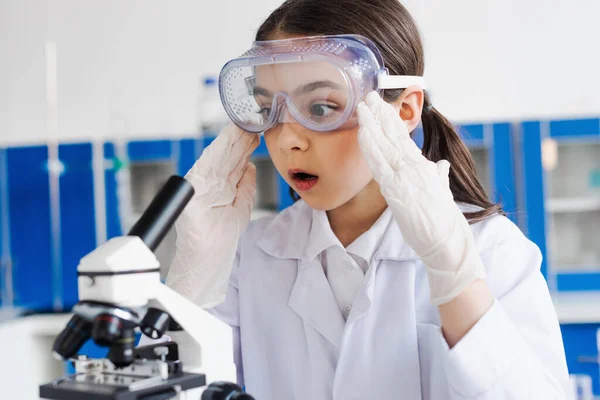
[{"x1": 166, "y1": 123, "x2": 260, "y2": 308}]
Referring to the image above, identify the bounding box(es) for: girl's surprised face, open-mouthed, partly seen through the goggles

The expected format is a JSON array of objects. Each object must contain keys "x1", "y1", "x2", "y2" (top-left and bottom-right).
[{"x1": 255, "y1": 59, "x2": 373, "y2": 211}]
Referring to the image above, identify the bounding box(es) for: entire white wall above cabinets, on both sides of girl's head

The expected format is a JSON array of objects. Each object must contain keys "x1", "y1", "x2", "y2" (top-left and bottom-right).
[{"x1": 0, "y1": 0, "x2": 600, "y2": 147}]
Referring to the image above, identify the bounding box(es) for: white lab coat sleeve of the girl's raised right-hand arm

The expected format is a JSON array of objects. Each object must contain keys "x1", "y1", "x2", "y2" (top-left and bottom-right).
[{"x1": 444, "y1": 220, "x2": 569, "y2": 400}]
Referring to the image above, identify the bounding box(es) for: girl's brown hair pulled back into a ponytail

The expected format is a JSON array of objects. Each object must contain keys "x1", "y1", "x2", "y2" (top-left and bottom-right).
[{"x1": 256, "y1": 0, "x2": 503, "y2": 222}]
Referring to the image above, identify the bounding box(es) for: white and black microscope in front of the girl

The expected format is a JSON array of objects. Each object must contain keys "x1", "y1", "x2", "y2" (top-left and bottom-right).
[{"x1": 39, "y1": 176, "x2": 253, "y2": 400}]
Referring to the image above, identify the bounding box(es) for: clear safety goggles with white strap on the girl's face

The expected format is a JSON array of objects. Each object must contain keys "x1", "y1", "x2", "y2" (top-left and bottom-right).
[{"x1": 219, "y1": 35, "x2": 425, "y2": 133}]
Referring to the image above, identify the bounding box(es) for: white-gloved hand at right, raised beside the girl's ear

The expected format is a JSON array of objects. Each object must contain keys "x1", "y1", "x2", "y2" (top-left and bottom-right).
[{"x1": 358, "y1": 92, "x2": 485, "y2": 305}]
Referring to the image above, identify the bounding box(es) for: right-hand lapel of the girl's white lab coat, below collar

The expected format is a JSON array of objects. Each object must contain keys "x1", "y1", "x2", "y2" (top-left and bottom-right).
[{"x1": 333, "y1": 259, "x2": 422, "y2": 400}]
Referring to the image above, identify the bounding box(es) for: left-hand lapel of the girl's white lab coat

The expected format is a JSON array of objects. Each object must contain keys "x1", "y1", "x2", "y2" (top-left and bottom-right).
[{"x1": 288, "y1": 258, "x2": 344, "y2": 349}]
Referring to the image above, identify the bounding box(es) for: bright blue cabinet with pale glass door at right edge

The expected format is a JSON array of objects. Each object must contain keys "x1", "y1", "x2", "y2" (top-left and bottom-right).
[{"x1": 520, "y1": 118, "x2": 600, "y2": 291}]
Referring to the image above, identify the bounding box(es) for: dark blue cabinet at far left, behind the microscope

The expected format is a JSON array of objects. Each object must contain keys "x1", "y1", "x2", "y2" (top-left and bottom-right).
[{"x1": 3, "y1": 143, "x2": 96, "y2": 311}]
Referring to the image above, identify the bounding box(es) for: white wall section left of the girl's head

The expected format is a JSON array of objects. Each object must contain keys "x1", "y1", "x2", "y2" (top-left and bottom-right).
[{"x1": 0, "y1": 0, "x2": 279, "y2": 146}]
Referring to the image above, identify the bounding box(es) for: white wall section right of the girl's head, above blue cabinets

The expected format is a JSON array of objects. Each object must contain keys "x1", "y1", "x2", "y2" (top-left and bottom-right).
[{"x1": 418, "y1": 0, "x2": 600, "y2": 120}]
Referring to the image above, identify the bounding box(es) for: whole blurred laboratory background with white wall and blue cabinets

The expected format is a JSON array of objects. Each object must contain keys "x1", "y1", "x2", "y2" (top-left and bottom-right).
[{"x1": 0, "y1": 0, "x2": 600, "y2": 399}]
